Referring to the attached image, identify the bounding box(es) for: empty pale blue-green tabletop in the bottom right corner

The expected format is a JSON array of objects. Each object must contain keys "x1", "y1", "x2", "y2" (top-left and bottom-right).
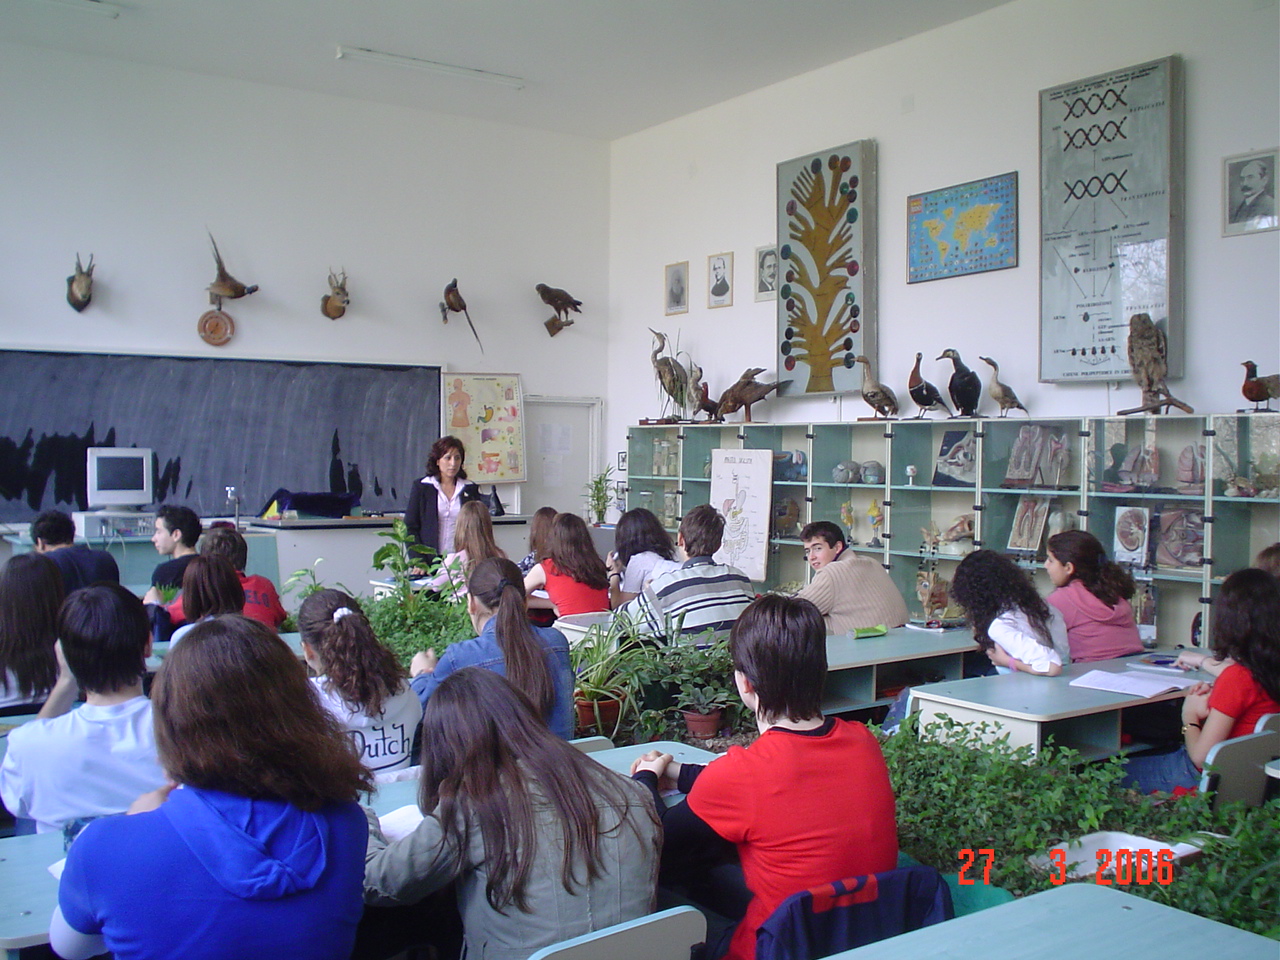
[{"x1": 827, "y1": 881, "x2": 1277, "y2": 960}]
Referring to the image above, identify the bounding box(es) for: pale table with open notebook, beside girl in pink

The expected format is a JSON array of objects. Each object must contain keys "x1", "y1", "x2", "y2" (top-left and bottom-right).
[{"x1": 911, "y1": 658, "x2": 1212, "y2": 759}]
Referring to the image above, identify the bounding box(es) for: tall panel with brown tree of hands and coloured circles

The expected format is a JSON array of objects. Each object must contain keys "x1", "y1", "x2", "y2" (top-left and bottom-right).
[{"x1": 777, "y1": 140, "x2": 877, "y2": 396}]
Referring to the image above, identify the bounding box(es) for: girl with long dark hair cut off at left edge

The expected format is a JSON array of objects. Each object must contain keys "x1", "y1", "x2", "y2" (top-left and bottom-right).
[{"x1": 0, "y1": 553, "x2": 63, "y2": 707}]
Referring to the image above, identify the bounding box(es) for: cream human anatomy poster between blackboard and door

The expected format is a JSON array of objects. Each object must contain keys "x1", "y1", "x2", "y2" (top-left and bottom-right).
[{"x1": 440, "y1": 372, "x2": 526, "y2": 484}]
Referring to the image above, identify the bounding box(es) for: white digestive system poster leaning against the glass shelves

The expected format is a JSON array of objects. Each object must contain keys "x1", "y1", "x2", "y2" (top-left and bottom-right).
[{"x1": 712, "y1": 451, "x2": 773, "y2": 580}]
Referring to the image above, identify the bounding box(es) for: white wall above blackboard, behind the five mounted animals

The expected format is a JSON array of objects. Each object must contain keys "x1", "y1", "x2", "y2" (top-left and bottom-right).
[{"x1": 0, "y1": 45, "x2": 608, "y2": 396}]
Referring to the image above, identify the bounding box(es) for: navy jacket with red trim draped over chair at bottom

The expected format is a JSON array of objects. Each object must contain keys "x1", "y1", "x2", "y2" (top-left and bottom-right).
[{"x1": 755, "y1": 864, "x2": 955, "y2": 960}]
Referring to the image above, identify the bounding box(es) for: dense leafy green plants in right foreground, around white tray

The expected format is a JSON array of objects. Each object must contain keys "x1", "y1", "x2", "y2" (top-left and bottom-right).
[{"x1": 884, "y1": 718, "x2": 1280, "y2": 940}]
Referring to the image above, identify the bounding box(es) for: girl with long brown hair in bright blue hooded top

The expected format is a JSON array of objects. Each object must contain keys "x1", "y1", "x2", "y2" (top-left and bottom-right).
[{"x1": 49, "y1": 616, "x2": 372, "y2": 960}]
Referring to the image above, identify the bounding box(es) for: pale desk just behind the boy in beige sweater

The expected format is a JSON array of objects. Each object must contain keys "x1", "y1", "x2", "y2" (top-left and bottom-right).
[{"x1": 822, "y1": 627, "x2": 978, "y2": 713}]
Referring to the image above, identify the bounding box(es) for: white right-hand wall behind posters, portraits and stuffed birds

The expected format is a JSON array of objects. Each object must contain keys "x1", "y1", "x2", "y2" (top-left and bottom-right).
[{"x1": 607, "y1": 0, "x2": 1280, "y2": 449}]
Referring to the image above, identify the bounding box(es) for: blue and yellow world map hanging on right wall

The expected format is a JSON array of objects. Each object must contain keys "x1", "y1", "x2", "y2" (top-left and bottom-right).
[{"x1": 906, "y1": 172, "x2": 1018, "y2": 283}]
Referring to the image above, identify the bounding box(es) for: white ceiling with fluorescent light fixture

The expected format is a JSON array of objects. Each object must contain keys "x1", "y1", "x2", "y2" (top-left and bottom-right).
[{"x1": 0, "y1": 0, "x2": 1009, "y2": 141}]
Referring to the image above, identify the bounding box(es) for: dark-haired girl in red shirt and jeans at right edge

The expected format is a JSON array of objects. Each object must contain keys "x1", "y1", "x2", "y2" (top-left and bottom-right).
[{"x1": 1121, "y1": 567, "x2": 1280, "y2": 794}]
